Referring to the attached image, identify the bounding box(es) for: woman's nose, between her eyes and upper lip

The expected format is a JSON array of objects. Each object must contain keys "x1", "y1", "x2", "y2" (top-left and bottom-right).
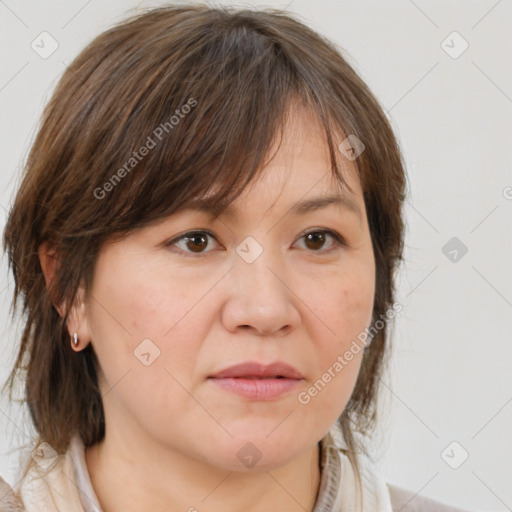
[{"x1": 222, "y1": 243, "x2": 300, "y2": 336}]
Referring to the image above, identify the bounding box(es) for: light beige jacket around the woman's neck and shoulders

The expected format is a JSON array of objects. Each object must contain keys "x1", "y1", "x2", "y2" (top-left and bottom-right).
[{"x1": 0, "y1": 434, "x2": 469, "y2": 512}]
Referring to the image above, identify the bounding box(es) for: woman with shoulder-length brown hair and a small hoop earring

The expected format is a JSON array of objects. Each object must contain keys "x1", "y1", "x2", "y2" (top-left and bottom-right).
[{"x1": 2, "y1": 5, "x2": 472, "y2": 512}]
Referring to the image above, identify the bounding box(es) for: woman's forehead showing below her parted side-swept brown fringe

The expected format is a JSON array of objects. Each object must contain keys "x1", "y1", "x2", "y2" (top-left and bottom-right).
[{"x1": 175, "y1": 105, "x2": 364, "y2": 226}]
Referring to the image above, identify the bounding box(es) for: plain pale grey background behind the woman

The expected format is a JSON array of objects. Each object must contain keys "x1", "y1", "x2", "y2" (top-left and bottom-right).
[{"x1": 0, "y1": 0, "x2": 512, "y2": 511}]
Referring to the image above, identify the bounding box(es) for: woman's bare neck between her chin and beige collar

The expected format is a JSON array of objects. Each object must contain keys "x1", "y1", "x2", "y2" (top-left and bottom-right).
[{"x1": 85, "y1": 429, "x2": 320, "y2": 512}]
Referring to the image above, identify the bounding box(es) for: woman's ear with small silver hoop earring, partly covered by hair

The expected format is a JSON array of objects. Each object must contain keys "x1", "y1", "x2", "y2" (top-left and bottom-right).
[{"x1": 38, "y1": 242, "x2": 90, "y2": 348}]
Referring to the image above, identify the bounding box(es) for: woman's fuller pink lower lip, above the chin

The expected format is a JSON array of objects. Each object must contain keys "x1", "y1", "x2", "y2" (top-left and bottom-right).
[{"x1": 210, "y1": 377, "x2": 302, "y2": 400}]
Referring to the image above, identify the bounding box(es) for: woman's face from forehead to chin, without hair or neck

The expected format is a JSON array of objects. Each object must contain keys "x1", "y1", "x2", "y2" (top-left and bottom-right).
[{"x1": 79, "y1": 108, "x2": 375, "y2": 471}]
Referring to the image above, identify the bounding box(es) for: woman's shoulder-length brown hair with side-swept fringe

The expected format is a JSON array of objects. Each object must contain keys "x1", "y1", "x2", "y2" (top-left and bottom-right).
[{"x1": 3, "y1": 4, "x2": 406, "y2": 504}]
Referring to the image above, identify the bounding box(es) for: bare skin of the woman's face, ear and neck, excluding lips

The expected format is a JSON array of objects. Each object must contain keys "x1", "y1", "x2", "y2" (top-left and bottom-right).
[{"x1": 40, "y1": 105, "x2": 375, "y2": 512}]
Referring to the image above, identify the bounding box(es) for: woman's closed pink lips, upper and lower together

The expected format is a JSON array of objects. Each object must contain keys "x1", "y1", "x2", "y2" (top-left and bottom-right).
[{"x1": 208, "y1": 361, "x2": 304, "y2": 400}]
